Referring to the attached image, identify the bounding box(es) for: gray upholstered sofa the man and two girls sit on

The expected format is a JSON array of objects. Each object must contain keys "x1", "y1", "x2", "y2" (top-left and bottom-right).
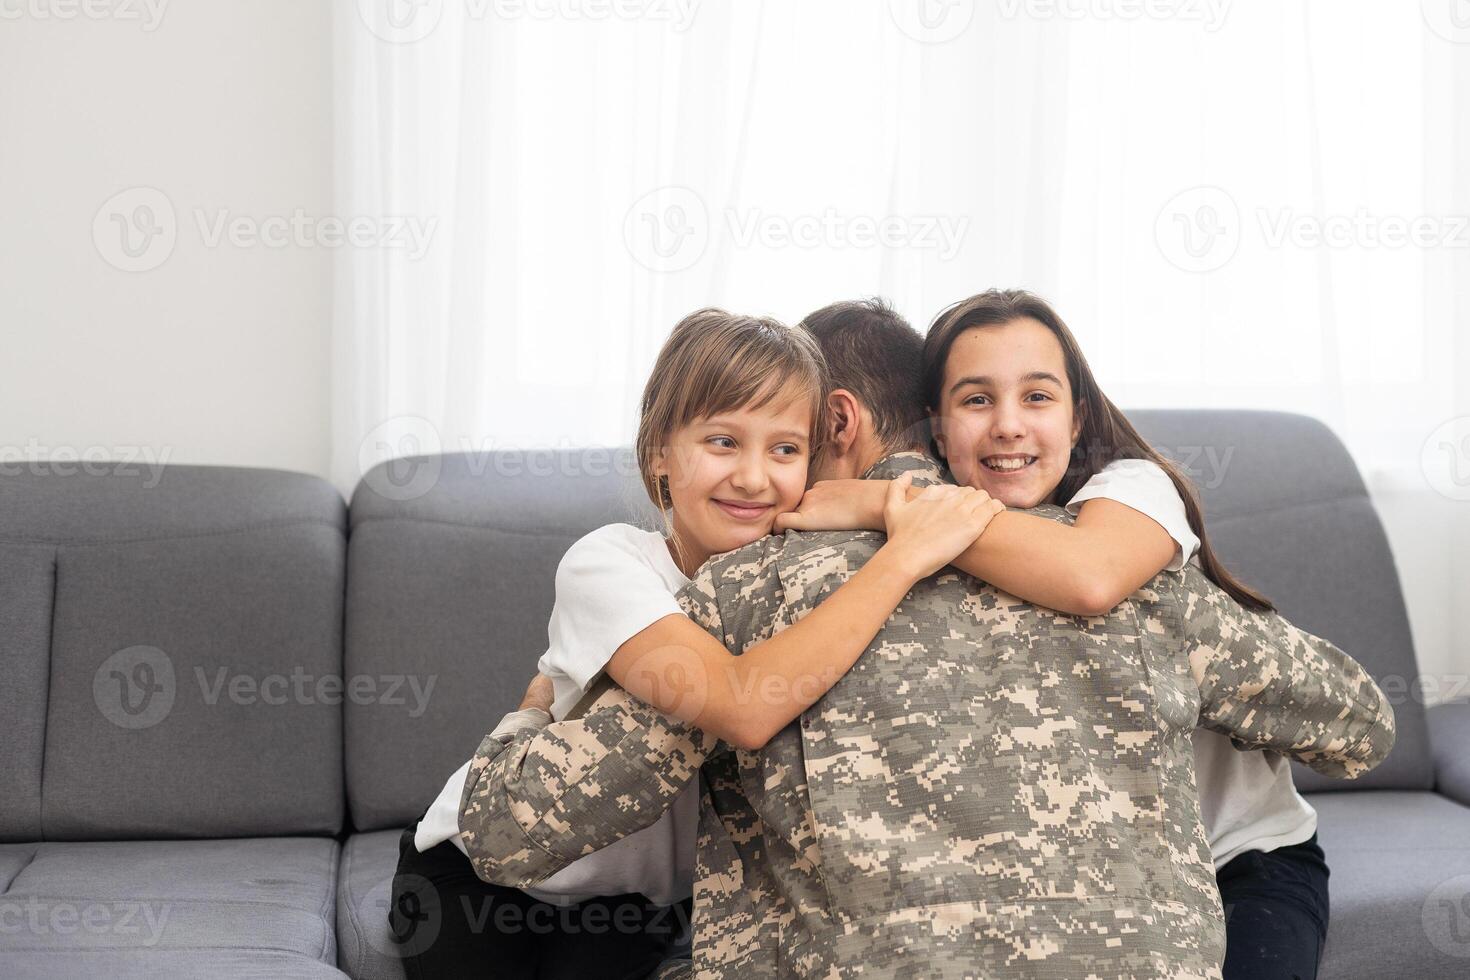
[{"x1": 0, "y1": 411, "x2": 1470, "y2": 980}]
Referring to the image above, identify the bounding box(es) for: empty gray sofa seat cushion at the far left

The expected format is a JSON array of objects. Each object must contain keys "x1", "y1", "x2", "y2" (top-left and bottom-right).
[{"x1": 0, "y1": 837, "x2": 340, "y2": 977}]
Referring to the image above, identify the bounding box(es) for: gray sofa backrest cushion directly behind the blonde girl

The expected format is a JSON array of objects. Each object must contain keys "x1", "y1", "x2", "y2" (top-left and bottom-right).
[{"x1": 345, "y1": 450, "x2": 659, "y2": 830}]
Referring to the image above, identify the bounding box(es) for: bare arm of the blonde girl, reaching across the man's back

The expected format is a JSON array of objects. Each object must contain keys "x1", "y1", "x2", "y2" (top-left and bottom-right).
[{"x1": 607, "y1": 478, "x2": 1001, "y2": 749}]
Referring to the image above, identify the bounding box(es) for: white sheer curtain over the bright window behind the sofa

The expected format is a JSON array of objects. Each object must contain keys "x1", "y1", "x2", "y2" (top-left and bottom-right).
[{"x1": 332, "y1": 0, "x2": 1470, "y2": 696}]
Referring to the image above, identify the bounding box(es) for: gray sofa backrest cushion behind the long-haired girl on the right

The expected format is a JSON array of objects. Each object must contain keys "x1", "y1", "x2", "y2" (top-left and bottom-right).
[{"x1": 1129, "y1": 410, "x2": 1433, "y2": 790}]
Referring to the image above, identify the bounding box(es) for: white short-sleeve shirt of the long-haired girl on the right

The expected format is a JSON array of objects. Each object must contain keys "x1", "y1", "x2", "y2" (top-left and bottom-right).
[{"x1": 1067, "y1": 460, "x2": 1317, "y2": 868}]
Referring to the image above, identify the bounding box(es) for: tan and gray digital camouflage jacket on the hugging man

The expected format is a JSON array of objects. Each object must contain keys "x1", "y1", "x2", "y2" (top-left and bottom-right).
[{"x1": 460, "y1": 454, "x2": 1394, "y2": 980}]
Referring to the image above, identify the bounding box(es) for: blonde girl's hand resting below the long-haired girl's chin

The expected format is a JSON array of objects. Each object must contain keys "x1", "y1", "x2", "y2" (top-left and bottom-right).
[{"x1": 883, "y1": 473, "x2": 1005, "y2": 582}]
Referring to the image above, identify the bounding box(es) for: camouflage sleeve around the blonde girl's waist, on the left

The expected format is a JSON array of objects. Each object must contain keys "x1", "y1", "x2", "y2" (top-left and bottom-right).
[{"x1": 460, "y1": 675, "x2": 716, "y2": 887}]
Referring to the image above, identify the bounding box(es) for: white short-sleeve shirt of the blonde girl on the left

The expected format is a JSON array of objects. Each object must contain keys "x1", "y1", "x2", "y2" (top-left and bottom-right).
[{"x1": 413, "y1": 525, "x2": 700, "y2": 905}]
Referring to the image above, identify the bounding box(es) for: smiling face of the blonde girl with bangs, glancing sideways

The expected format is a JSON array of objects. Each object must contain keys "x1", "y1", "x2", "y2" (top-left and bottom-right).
[{"x1": 654, "y1": 394, "x2": 811, "y2": 574}]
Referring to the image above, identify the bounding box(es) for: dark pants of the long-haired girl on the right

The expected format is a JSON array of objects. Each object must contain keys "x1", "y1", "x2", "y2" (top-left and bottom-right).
[{"x1": 1216, "y1": 835, "x2": 1329, "y2": 980}]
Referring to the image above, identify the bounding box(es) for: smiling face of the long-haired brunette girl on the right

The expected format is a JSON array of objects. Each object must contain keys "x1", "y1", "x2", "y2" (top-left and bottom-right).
[{"x1": 933, "y1": 317, "x2": 1082, "y2": 507}]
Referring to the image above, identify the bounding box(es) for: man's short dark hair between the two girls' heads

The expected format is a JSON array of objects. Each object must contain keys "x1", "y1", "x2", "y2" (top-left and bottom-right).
[{"x1": 801, "y1": 297, "x2": 928, "y2": 451}]
